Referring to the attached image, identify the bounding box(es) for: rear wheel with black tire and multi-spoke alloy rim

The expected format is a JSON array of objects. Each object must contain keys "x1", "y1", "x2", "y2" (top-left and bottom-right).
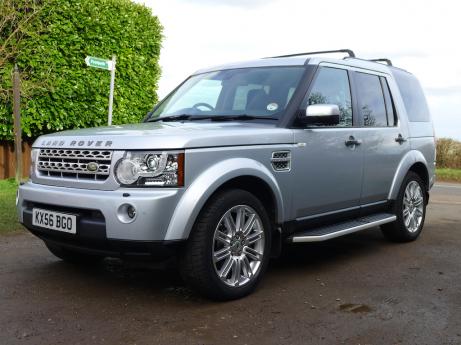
[{"x1": 381, "y1": 171, "x2": 427, "y2": 242}]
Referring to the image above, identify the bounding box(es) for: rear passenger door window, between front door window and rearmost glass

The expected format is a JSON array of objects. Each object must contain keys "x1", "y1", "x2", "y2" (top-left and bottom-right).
[{"x1": 355, "y1": 72, "x2": 387, "y2": 127}]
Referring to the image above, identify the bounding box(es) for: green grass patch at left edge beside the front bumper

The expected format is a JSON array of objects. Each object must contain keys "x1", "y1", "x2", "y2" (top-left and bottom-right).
[{"x1": 0, "y1": 179, "x2": 23, "y2": 235}]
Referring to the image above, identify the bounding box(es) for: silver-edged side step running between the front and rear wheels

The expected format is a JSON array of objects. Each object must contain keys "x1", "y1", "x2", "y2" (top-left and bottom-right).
[{"x1": 288, "y1": 213, "x2": 397, "y2": 242}]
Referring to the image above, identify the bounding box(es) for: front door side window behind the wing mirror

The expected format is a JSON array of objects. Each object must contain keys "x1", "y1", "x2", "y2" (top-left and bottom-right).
[{"x1": 306, "y1": 67, "x2": 352, "y2": 127}]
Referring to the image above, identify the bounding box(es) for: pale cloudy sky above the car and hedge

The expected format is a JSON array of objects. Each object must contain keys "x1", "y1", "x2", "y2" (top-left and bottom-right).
[{"x1": 136, "y1": 0, "x2": 461, "y2": 139}]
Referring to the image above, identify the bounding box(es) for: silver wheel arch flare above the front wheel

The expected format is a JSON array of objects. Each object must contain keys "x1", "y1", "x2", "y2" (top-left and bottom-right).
[{"x1": 165, "y1": 158, "x2": 285, "y2": 240}]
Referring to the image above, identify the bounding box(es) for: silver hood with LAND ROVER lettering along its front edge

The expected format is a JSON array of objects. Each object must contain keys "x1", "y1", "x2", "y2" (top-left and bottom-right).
[{"x1": 33, "y1": 122, "x2": 293, "y2": 150}]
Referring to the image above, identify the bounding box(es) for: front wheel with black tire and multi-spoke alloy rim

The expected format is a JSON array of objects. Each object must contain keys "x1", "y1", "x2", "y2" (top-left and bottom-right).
[{"x1": 180, "y1": 189, "x2": 272, "y2": 300}]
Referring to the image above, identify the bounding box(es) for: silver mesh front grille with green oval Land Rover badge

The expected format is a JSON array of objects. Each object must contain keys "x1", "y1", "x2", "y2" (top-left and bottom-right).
[{"x1": 37, "y1": 149, "x2": 112, "y2": 181}]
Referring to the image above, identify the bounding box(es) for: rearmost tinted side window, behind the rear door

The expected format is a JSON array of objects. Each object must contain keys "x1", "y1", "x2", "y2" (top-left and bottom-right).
[{"x1": 392, "y1": 70, "x2": 431, "y2": 122}]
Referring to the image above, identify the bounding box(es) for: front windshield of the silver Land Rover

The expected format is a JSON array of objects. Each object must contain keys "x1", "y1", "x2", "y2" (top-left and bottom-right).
[{"x1": 147, "y1": 66, "x2": 304, "y2": 121}]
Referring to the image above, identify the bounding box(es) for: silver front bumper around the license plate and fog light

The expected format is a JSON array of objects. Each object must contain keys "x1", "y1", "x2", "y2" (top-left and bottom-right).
[{"x1": 17, "y1": 182, "x2": 183, "y2": 245}]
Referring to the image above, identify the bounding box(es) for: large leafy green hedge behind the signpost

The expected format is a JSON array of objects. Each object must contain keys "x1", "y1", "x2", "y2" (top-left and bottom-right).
[{"x1": 0, "y1": 0, "x2": 162, "y2": 140}]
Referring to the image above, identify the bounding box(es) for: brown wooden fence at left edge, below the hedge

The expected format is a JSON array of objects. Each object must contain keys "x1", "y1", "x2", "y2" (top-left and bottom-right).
[{"x1": 0, "y1": 141, "x2": 32, "y2": 180}]
